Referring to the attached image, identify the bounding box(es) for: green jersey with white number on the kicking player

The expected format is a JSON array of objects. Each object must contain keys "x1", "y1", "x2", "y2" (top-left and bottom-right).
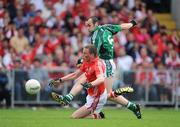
[{"x1": 91, "y1": 24, "x2": 121, "y2": 60}]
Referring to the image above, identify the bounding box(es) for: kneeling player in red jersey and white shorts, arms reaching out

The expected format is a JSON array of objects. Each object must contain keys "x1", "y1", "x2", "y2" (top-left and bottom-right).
[{"x1": 52, "y1": 45, "x2": 107, "y2": 118}]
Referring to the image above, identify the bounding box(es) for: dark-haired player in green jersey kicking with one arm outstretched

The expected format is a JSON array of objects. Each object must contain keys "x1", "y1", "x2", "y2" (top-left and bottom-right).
[{"x1": 51, "y1": 17, "x2": 141, "y2": 119}]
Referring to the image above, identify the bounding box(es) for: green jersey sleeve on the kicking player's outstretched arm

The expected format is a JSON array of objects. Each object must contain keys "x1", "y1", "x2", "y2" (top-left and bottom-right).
[{"x1": 102, "y1": 24, "x2": 122, "y2": 35}]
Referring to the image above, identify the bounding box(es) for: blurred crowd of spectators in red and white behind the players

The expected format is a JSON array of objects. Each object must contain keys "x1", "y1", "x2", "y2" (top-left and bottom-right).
[{"x1": 0, "y1": 0, "x2": 180, "y2": 108}]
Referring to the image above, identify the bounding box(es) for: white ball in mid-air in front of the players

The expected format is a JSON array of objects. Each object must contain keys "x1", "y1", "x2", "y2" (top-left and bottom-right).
[{"x1": 25, "y1": 79, "x2": 41, "y2": 94}]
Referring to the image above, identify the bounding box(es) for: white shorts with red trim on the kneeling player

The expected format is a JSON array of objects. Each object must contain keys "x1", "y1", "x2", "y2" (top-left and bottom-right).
[{"x1": 85, "y1": 90, "x2": 107, "y2": 113}]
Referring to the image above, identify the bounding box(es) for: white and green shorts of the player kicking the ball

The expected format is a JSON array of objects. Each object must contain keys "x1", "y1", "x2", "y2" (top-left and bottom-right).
[{"x1": 101, "y1": 59, "x2": 116, "y2": 77}]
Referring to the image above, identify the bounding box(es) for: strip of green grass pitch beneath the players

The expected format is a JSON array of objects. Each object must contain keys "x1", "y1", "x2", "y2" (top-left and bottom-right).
[{"x1": 0, "y1": 108, "x2": 180, "y2": 127}]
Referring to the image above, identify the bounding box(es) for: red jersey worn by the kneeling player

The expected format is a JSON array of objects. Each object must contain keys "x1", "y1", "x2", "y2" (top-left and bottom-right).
[{"x1": 80, "y1": 58, "x2": 105, "y2": 96}]
